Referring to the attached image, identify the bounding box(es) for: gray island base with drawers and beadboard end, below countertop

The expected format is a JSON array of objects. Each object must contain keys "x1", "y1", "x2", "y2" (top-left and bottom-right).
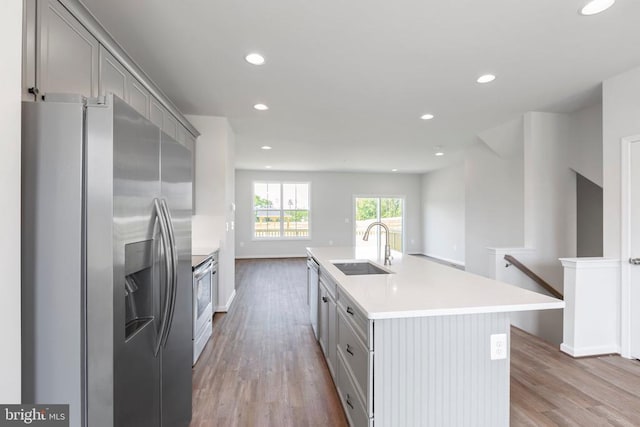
[{"x1": 317, "y1": 266, "x2": 510, "y2": 427}]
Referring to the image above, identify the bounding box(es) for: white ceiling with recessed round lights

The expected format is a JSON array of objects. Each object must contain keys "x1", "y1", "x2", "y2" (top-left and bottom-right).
[{"x1": 83, "y1": 0, "x2": 640, "y2": 172}]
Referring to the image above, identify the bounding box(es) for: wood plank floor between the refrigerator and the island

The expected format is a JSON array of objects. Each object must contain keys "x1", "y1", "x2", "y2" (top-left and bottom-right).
[{"x1": 191, "y1": 259, "x2": 347, "y2": 427}]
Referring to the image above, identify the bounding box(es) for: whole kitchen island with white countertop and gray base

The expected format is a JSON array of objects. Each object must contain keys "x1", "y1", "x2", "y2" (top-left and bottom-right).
[{"x1": 307, "y1": 247, "x2": 564, "y2": 427}]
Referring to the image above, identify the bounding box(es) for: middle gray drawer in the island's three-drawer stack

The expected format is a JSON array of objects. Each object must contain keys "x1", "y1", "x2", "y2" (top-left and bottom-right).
[{"x1": 338, "y1": 312, "x2": 373, "y2": 402}]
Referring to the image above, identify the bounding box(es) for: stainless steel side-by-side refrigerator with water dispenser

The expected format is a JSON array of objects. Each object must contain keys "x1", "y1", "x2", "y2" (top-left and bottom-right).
[{"x1": 22, "y1": 95, "x2": 193, "y2": 427}]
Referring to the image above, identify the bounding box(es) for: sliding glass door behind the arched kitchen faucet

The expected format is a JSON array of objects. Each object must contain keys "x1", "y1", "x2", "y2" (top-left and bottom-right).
[{"x1": 354, "y1": 197, "x2": 404, "y2": 253}]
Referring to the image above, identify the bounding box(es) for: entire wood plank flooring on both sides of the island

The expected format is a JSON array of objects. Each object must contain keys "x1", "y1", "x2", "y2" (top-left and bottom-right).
[{"x1": 191, "y1": 259, "x2": 640, "y2": 427}]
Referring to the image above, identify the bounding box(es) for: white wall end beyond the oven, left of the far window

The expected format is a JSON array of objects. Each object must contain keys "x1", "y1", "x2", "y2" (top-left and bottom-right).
[{"x1": 186, "y1": 116, "x2": 235, "y2": 311}]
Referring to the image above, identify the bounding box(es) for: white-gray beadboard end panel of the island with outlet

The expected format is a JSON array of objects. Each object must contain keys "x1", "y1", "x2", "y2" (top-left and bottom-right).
[{"x1": 373, "y1": 313, "x2": 511, "y2": 427}]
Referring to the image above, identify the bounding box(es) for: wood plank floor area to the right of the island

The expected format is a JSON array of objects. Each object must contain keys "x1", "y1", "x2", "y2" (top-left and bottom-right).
[{"x1": 511, "y1": 328, "x2": 640, "y2": 426}]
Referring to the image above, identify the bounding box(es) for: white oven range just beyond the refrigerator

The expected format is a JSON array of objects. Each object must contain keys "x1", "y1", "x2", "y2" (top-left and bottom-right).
[{"x1": 193, "y1": 256, "x2": 217, "y2": 365}]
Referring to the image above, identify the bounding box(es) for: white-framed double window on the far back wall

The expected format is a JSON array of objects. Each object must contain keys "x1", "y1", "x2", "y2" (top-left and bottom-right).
[{"x1": 253, "y1": 182, "x2": 310, "y2": 239}]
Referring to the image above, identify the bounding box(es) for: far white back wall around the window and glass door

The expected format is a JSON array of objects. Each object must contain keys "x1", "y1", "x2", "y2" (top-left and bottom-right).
[{"x1": 236, "y1": 170, "x2": 422, "y2": 258}]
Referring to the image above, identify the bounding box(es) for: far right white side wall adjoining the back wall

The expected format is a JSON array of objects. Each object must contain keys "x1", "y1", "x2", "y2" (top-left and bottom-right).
[{"x1": 422, "y1": 164, "x2": 465, "y2": 265}]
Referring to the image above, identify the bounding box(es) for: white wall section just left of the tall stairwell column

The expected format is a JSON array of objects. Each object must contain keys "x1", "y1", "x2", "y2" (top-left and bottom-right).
[{"x1": 464, "y1": 140, "x2": 524, "y2": 276}]
